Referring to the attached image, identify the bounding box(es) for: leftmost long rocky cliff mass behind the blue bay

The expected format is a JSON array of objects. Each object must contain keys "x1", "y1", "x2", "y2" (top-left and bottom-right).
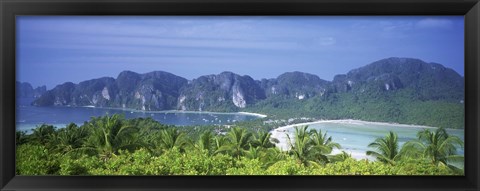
[{"x1": 33, "y1": 71, "x2": 187, "y2": 110}]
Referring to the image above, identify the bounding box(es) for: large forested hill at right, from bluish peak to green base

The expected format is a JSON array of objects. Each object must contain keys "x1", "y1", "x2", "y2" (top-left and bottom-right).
[{"x1": 246, "y1": 58, "x2": 465, "y2": 128}]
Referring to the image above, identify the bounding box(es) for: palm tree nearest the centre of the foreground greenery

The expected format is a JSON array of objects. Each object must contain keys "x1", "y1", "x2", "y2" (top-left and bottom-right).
[{"x1": 217, "y1": 127, "x2": 252, "y2": 158}]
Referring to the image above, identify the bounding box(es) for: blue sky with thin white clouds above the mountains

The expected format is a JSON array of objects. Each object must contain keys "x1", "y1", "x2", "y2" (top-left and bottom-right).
[{"x1": 16, "y1": 16, "x2": 464, "y2": 89}]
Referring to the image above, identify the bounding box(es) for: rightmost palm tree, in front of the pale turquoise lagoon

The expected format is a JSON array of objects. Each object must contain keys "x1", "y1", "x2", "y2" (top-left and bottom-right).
[{"x1": 405, "y1": 128, "x2": 464, "y2": 169}]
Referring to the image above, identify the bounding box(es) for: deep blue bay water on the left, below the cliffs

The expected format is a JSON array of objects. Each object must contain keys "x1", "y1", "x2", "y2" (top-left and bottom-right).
[{"x1": 16, "y1": 100, "x2": 259, "y2": 132}]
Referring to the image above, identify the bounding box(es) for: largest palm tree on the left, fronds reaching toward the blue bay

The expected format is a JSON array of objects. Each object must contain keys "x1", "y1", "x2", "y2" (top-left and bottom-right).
[{"x1": 83, "y1": 114, "x2": 141, "y2": 160}]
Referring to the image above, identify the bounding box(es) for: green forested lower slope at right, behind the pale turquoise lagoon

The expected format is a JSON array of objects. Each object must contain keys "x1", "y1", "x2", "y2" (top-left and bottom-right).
[{"x1": 244, "y1": 89, "x2": 465, "y2": 129}]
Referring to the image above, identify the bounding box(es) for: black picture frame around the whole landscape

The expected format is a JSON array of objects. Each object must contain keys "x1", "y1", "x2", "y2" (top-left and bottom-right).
[{"x1": 0, "y1": 0, "x2": 480, "y2": 191}]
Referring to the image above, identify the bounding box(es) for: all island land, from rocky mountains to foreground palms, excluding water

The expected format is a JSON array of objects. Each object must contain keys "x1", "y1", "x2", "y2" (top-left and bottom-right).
[{"x1": 16, "y1": 58, "x2": 464, "y2": 175}]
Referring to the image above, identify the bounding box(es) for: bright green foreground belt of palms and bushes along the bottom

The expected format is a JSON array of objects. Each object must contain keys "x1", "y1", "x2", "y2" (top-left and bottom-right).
[{"x1": 16, "y1": 115, "x2": 463, "y2": 175}]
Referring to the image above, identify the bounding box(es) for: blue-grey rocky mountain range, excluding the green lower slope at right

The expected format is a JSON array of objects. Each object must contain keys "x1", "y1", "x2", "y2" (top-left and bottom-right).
[{"x1": 27, "y1": 58, "x2": 464, "y2": 111}]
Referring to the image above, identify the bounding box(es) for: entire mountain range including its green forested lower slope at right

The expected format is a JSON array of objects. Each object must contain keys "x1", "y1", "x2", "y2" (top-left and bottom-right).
[{"x1": 27, "y1": 57, "x2": 465, "y2": 129}]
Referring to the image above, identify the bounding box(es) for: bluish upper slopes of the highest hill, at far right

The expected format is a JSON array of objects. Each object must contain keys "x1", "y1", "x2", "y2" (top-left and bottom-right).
[{"x1": 332, "y1": 58, "x2": 465, "y2": 100}]
